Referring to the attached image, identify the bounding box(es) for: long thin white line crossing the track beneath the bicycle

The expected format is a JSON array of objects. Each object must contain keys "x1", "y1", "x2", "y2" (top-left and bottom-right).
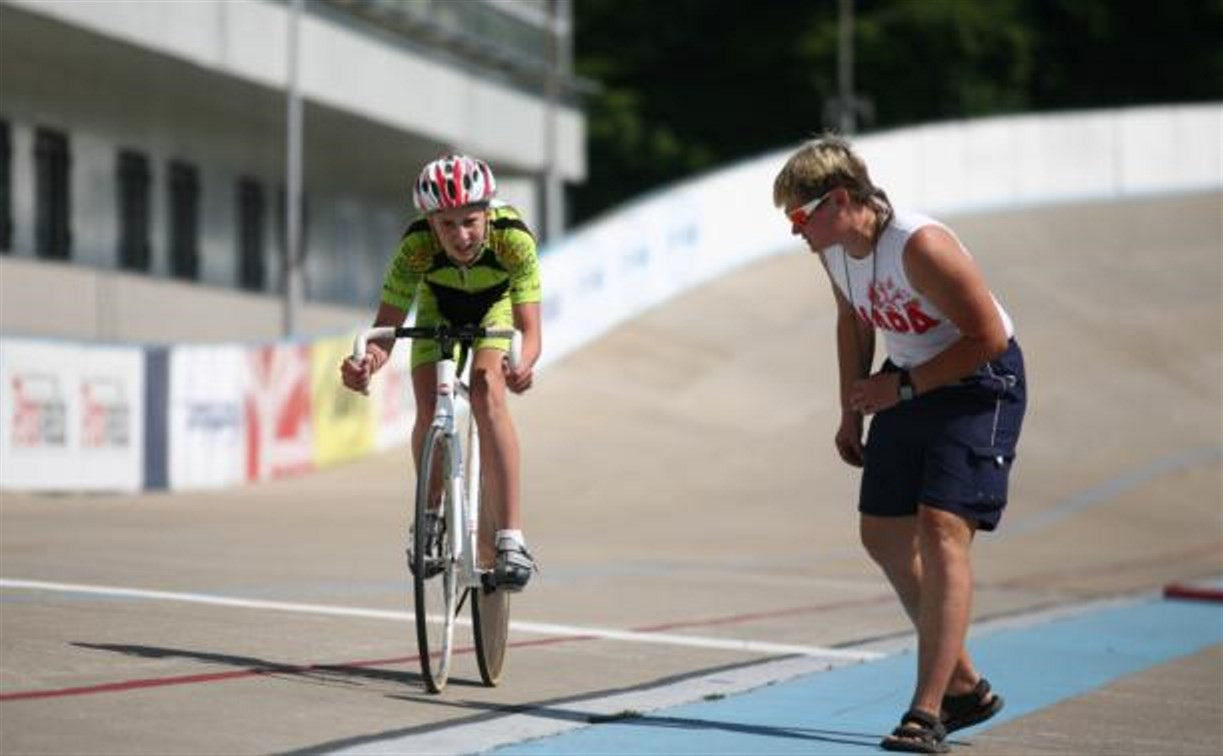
[{"x1": 0, "y1": 577, "x2": 883, "y2": 662}]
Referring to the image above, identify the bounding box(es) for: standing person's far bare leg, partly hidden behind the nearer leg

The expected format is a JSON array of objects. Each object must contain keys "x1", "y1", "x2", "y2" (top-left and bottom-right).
[{"x1": 860, "y1": 515, "x2": 980, "y2": 695}]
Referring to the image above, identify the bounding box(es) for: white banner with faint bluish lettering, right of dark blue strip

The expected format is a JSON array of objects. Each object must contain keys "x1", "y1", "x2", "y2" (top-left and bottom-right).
[{"x1": 169, "y1": 346, "x2": 248, "y2": 489}]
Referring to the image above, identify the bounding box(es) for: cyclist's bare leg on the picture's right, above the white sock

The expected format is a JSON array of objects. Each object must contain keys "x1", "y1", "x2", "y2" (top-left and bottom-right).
[{"x1": 471, "y1": 349, "x2": 522, "y2": 561}]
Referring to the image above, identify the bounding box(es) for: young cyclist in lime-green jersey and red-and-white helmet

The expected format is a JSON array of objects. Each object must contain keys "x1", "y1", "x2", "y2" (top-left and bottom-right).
[{"x1": 340, "y1": 154, "x2": 541, "y2": 591}]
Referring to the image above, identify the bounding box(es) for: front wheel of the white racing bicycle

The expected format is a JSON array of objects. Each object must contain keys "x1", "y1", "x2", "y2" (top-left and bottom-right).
[{"x1": 411, "y1": 428, "x2": 459, "y2": 692}]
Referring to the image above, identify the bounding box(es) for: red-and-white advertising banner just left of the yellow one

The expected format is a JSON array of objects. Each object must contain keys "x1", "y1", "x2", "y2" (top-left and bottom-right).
[{"x1": 245, "y1": 344, "x2": 314, "y2": 481}]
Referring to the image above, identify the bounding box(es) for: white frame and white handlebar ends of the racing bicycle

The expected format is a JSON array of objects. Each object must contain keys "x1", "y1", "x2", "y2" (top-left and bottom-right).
[{"x1": 352, "y1": 325, "x2": 522, "y2": 591}]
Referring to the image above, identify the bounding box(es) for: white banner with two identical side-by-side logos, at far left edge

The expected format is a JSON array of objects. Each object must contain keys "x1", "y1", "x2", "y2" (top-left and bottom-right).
[{"x1": 0, "y1": 339, "x2": 144, "y2": 491}]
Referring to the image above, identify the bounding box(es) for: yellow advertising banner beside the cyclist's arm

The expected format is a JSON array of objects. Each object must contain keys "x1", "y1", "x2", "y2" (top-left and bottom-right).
[{"x1": 311, "y1": 336, "x2": 371, "y2": 467}]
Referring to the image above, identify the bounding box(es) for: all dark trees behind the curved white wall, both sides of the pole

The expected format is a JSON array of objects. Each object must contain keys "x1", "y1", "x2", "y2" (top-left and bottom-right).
[{"x1": 571, "y1": 0, "x2": 1223, "y2": 221}]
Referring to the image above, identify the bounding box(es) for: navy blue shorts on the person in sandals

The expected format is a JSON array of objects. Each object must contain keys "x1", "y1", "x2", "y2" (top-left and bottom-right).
[{"x1": 857, "y1": 339, "x2": 1027, "y2": 531}]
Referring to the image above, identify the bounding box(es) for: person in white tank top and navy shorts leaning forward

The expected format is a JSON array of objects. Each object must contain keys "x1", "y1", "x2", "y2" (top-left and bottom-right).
[{"x1": 773, "y1": 136, "x2": 1027, "y2": 752}]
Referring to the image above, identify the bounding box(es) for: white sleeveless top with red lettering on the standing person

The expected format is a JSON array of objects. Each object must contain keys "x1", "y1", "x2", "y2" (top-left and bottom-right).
[{"x1": 823, "y1": 212, "x2": 1015, "y2": 368}]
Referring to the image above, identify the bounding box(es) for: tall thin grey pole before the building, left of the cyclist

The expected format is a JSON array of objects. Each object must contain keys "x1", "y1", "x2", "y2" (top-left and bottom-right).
[{"x1": 284, "y1": 0, "x2": 302, "y2": 338}]
